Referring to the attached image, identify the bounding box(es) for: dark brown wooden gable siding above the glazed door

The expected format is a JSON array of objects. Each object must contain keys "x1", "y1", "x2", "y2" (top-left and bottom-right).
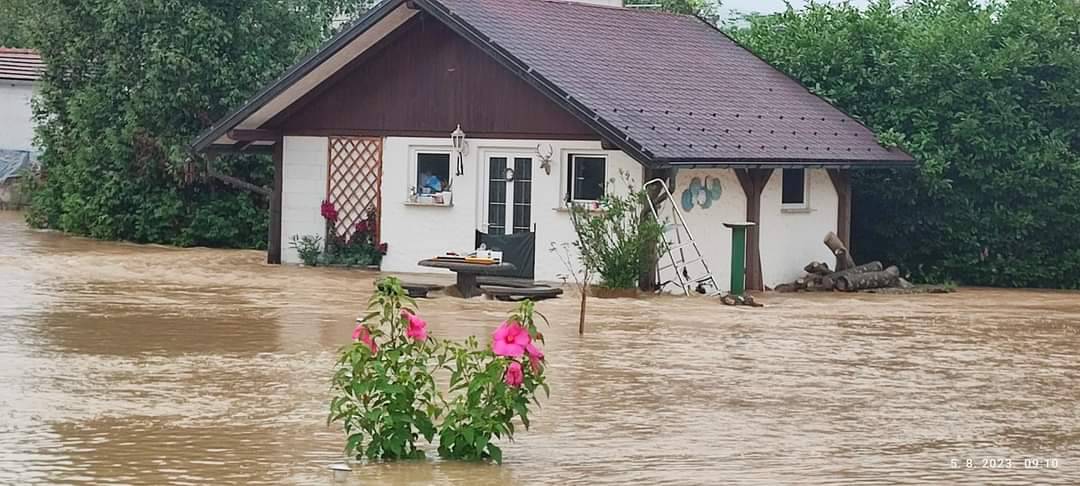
[{"x1": 266, "y1": 14, "x2": 599, "y2": 139}]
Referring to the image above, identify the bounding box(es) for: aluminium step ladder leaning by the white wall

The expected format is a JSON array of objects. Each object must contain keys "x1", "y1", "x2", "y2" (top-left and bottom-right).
[{"x1": 643, "y1": 179, "x2": 721, "y2": 296}]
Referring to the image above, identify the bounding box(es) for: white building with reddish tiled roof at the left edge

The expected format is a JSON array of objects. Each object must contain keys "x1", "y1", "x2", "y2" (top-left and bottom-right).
[{"x1": 0, "y1": 48, "x2": 44, "y2": 208}]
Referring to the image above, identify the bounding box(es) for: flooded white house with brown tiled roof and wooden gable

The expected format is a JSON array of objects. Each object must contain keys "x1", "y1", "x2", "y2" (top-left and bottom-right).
[{"x1": 192, "y1": 0, "x2": 914, "y2": 288}]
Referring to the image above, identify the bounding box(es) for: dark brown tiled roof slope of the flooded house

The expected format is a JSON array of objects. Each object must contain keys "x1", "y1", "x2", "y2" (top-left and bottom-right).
[{"x1": 435, "y1": 0, "x2": 912, "y2": 165}]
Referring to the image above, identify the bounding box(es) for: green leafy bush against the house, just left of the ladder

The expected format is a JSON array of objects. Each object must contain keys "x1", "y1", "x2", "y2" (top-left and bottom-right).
[{"x1": 570, "y1": 174, "x2": 663, "y2": 288}]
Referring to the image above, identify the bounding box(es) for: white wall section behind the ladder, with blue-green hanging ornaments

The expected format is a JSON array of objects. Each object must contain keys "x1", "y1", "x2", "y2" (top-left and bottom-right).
[{"x1": 660, "y1": 168, "x2": 746, "y2": 292}]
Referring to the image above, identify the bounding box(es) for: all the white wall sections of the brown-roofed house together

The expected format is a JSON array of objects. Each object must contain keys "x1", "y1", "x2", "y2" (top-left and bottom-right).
[{"x1": 282, "y1": 132, "x2": 838, "y2": 291}]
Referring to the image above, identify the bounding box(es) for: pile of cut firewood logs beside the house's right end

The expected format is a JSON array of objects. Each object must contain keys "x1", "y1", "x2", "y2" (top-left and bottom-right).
[{"x1": 775, "y1": 232, "x2": 910, "y2": 292}]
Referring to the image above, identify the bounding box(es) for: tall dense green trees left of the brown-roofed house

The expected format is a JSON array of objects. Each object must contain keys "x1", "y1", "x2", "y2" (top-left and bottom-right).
[{"x1": 24, "y1": 0, "x2": 364, "y2": 247}]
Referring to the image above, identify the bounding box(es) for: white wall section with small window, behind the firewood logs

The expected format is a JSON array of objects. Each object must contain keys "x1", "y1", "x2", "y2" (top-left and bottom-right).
[{"x1": 760, "y1": 168, "x2": 839, "y2": 287}]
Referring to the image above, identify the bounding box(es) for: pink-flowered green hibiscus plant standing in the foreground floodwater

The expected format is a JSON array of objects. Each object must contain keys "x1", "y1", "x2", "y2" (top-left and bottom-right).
[{"x1": 328, "y1": 278, "x2": 548, "y2": 462}]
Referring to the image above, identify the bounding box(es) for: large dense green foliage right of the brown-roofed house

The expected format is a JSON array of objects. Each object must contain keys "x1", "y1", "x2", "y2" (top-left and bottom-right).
[{"x1": 733, "y1": 0, "x2": 1080, "y2": 287}]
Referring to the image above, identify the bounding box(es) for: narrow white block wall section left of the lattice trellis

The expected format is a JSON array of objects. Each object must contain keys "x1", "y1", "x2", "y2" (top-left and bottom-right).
[{"x1": 281, "y1": 137, "x2": 328, "y2": 264}]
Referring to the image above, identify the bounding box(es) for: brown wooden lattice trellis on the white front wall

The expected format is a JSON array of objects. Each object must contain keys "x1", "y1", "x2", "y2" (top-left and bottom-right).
[{"x1": 326, "y1": 137, "x2": 382, "y2": 242}]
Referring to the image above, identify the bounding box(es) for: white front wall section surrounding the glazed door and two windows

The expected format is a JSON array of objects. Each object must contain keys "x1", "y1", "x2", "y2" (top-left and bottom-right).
[{"x1": 378, "y1": 137, "x2": 642, "y2": 282}]
